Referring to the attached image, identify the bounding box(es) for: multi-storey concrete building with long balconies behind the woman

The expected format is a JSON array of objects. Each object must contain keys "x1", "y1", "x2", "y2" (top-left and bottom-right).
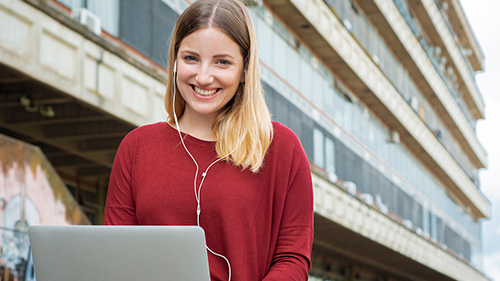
[{"x1": 0, "y1": 0, "x2": 490, "y2": 281}]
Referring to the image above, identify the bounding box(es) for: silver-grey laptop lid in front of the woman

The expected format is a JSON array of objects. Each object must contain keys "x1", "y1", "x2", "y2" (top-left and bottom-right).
[{"x1": 29, "y1": 225, "x2": 210, "y2": 281}]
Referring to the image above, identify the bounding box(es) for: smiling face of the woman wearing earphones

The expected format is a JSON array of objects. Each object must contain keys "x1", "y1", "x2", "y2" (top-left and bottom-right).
[{"x1": 176, "y1": 27, "x2": 244, "y2": 121}]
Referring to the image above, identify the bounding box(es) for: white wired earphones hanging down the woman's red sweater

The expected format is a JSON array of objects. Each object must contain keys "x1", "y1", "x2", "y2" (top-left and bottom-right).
[{"x1": 172, "y1": 60, "x2": 240, "y2": 281}]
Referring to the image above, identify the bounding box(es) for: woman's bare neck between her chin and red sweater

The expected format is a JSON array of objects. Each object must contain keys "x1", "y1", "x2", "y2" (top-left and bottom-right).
[{"x1": 179, "y1": 108, "x2": 215, "y2": 141}]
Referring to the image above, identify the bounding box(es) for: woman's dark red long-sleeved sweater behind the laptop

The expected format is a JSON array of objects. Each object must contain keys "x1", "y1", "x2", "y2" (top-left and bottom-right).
[{"x1": 104, "y1": 122, "x2": 313, "y2": 281}]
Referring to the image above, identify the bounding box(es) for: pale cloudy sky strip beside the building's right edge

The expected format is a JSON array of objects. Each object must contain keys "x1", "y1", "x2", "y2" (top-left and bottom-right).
[{"x1": 460, "y1": 0, "x2": 500, "y2": 281}]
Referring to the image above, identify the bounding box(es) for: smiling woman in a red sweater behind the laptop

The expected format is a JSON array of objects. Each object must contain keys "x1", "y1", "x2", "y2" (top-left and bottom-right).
[{"x1": 104, "y1": 0, "x2": 313, "y2": 281}]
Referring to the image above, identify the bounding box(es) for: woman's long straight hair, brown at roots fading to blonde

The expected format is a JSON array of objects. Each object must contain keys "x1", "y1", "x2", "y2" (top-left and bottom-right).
[{"x1": 165, "y1": 0, "x2": 273, "y2": 173}]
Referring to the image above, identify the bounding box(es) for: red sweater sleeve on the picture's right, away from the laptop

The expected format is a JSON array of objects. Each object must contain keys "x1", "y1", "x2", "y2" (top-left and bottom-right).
[{"x1": 263, "y1": 132, "x2": 314, "y2": 281}]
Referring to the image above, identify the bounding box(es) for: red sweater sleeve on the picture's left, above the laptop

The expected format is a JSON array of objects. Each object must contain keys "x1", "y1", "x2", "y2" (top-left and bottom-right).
[{"x1": 104, "y1": 134, "x2": 138, "y2": 225}]
